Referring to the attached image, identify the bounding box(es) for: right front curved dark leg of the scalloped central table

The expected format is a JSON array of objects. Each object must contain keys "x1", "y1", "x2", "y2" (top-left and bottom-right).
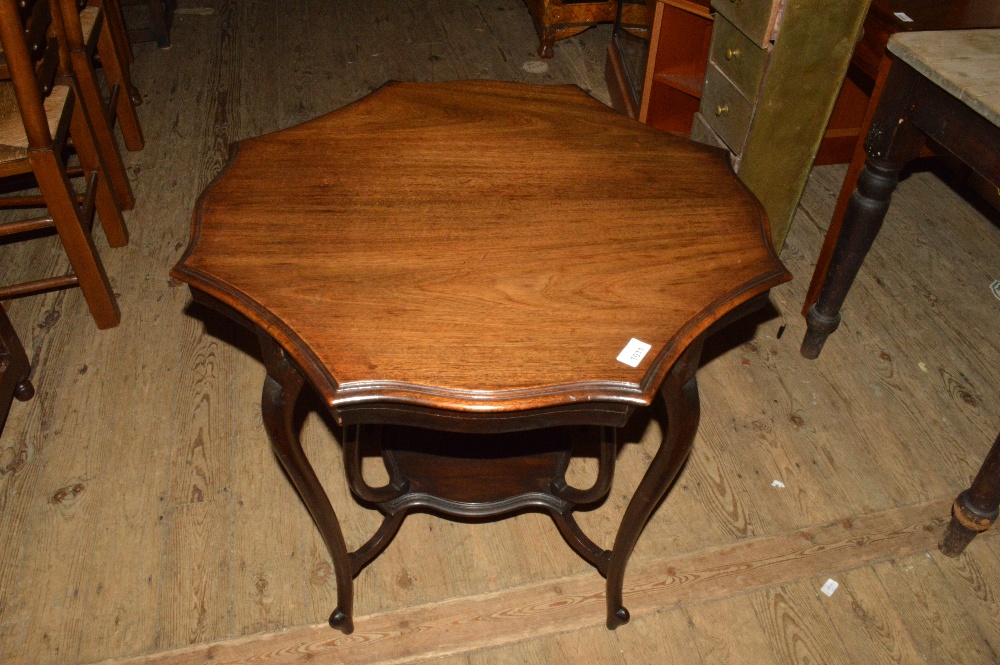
[{"x1": 607, "y1": 337, "x2": 704, "y2": 630}]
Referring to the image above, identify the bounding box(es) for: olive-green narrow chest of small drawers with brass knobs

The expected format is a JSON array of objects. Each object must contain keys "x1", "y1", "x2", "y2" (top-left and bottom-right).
[{"x1": 691, "y1": 0, "x2": 868, "y2": 249}]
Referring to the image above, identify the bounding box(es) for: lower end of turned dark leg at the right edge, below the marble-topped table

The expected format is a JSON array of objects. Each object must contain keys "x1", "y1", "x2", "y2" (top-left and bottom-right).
[{"x1": 938, "y1": 434, "x2": 1000, "y2": 556}]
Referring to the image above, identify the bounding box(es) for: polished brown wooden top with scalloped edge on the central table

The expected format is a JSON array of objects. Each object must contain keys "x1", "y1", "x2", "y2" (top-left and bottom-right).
[{"x1": 171, "y1": 81, "x2": 791, "y2": 413}]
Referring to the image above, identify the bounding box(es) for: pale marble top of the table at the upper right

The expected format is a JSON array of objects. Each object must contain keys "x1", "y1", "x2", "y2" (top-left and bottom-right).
[{"x1": 888, "y1": 29, "x2": 1000, "y2": 126}]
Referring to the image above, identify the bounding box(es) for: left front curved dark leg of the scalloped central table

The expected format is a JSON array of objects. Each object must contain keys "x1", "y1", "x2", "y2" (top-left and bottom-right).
[{"x1": 257, "y1": 331, "x2": 354, "y2": 634}]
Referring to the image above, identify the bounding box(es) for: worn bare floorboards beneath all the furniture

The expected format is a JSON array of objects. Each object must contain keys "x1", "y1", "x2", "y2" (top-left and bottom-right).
[{"x1": 0, "y1": 0, "x2": 1000, "y2": 665}]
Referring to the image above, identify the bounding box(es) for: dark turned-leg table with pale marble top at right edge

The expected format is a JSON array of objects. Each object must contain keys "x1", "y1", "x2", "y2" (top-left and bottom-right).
[{"x1": 802, "y1": 30, "x2": 1000, "y2": 556}]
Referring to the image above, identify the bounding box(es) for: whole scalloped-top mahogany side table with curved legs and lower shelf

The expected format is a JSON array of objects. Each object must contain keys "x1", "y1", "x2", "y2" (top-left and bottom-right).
[{"x1": 171, "y1": 81, "x2": 791, "y2": 633}]
